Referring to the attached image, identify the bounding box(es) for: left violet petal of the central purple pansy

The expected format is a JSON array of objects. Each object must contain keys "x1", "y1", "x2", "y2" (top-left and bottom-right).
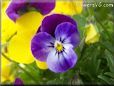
[{"x1": 31, "y1": 32, "x2": 54, "y2": 61}]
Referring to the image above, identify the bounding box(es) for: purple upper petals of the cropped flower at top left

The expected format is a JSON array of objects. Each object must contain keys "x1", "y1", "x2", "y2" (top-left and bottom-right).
[{"x1": 6, "y1": 0, "x2": 55, "y2": 21}]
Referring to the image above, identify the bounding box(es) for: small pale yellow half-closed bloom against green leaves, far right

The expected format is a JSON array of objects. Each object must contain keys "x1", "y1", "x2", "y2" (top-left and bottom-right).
[{"x1": 85, "y1": 24, "x2": 100, "y2": 44}]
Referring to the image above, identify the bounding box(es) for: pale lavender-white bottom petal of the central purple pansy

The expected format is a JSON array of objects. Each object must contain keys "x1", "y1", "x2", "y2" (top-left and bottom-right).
[{"x1": 47, "y1": 49, "x2": 77, "y2": 73}]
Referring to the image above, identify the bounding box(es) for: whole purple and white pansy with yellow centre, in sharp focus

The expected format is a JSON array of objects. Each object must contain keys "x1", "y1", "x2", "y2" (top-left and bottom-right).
[{"x1": 31, "y1": 14, "x2": 80, "y2": 73}]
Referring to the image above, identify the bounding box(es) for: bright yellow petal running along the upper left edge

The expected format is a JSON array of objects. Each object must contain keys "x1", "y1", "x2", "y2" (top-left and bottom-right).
[{"x1": 1, "y1": 2, "x2": 16, "y2": 44}]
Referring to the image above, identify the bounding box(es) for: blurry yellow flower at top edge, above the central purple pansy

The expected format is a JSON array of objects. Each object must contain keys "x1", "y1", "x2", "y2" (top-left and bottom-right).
[{"x1": 53, "y1": 0, "x2": 83, "y2": 15}]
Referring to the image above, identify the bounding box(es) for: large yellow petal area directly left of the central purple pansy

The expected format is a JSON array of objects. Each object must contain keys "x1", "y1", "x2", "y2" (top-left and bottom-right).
[{"x1": 8, "y1": 12, "x2": 43, "y2": 64}]
